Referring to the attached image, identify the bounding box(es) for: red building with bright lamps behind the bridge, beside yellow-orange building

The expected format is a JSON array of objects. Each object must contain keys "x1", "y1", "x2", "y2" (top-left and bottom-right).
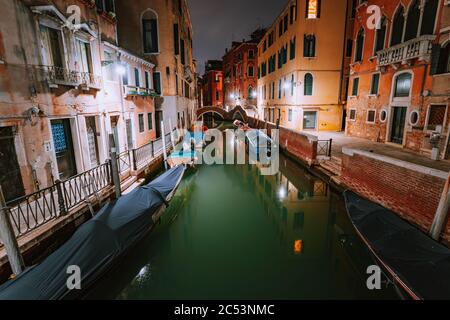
[{"x1": 223, "y1": 29, "x2": 264, "y2": 109}]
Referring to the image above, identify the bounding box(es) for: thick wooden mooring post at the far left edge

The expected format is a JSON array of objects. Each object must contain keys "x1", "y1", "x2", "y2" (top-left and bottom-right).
[{"x1": 0, "y1": 186, "x2": 25, "y2": 276}]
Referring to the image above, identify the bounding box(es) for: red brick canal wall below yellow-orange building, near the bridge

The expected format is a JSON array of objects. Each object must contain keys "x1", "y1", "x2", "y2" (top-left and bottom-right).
[{"x1": 248, "y1": 117, "x2": 317, "y2": 166}]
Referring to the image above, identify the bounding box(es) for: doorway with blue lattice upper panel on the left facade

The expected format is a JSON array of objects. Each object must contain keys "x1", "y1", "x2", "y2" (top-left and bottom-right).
[{"x1": 51, "y1": 119, "x2": 77, "y2": 180}]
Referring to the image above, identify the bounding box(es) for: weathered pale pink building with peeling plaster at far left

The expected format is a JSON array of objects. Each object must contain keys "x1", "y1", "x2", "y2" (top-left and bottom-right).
[{"x1": 0, "y1": 0, "x2": 155, "y2": 201}]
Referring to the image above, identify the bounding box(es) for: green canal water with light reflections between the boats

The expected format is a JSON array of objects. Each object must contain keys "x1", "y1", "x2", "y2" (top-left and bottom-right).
[{"x1": 87, "y1": 151, "x2": 396, "y2": 300}]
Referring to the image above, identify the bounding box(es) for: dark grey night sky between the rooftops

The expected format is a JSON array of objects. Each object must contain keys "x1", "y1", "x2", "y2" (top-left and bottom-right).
[{"x1": 187, "y1": 0, "x2": 287, "y2": 74}]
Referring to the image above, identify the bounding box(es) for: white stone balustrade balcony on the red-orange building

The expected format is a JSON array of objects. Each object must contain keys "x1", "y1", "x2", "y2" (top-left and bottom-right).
[{"x1": 377, "y1": 35, "x2": 435, "y2": 67}]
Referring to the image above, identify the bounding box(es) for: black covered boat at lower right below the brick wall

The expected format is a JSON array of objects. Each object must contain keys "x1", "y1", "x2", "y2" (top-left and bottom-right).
[{"x1": 344, "y1": 191, "x2": 450, "y2": 300}]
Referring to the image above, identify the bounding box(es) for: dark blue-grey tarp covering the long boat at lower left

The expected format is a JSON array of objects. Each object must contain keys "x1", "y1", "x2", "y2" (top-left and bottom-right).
[{"x1": 0, "y1": 166, "x2": 184, "y2": 300}]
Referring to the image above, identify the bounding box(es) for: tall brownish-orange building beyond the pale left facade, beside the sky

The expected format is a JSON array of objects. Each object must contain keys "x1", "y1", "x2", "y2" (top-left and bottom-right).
[{"x1": 116, "y1": 0, "x2": 197, "y2": 137}]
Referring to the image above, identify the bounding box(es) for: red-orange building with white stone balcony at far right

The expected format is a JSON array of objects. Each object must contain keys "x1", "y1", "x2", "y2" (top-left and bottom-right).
[{"x1": 347, "y1": 0, "x2": 450, "y2": 157}]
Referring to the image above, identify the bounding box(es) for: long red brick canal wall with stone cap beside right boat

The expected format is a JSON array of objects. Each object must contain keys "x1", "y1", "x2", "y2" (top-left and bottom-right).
[{"x1": 341, "y1": 149, "x2": 450, "y2": 244}]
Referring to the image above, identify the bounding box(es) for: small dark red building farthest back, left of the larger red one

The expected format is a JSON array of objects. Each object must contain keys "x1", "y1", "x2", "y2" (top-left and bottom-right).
[{"x1": 202, "y1": 60, "x2": 223, "y2": 107}]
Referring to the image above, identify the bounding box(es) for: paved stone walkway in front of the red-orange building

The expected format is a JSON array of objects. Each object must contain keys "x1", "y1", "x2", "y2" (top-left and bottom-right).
[{"x1": 314, "y1": 132, "x2": 450, "y2": 172}]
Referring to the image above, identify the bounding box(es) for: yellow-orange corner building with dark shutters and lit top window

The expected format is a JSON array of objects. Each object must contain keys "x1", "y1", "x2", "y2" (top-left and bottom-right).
[{"x1": 258, "y1": 0, "x2": 352, "y2": 131}]
